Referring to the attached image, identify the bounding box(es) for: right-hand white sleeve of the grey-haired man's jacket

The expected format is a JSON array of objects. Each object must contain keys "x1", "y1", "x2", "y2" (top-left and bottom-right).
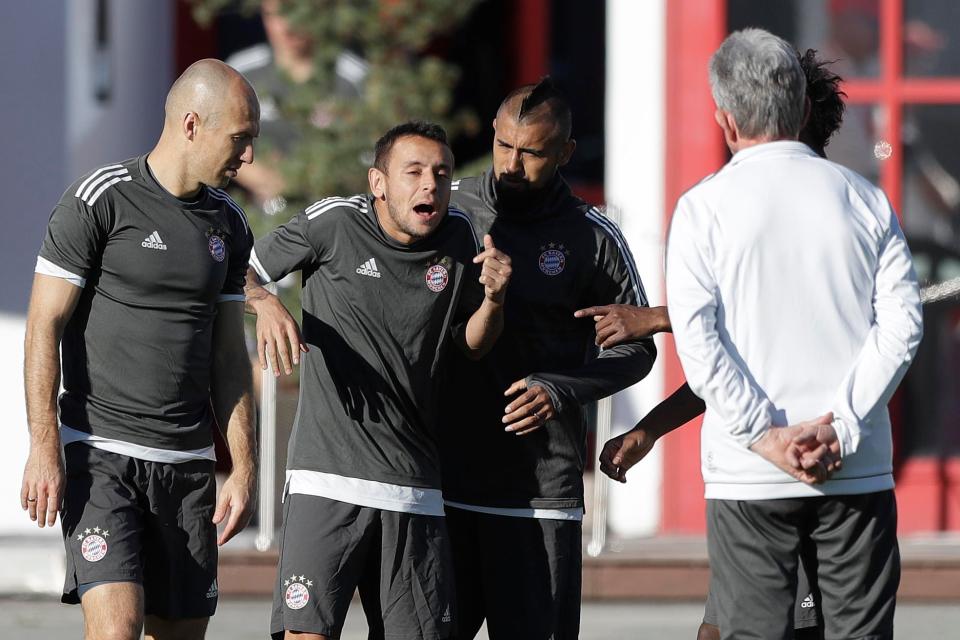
[{"x1": 831, "y1": 205, "x2": 923, "y2": 456}]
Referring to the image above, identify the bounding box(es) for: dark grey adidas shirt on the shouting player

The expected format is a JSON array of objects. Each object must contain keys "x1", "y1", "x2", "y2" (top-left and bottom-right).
[{"x1": 251, "y1": 195, "x2": 483, "y2": 489}]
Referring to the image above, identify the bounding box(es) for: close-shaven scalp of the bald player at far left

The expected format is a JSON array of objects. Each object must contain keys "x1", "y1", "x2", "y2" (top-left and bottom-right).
[{"x1": 164, "y1": 58, "x2": 260, "y2": 127}]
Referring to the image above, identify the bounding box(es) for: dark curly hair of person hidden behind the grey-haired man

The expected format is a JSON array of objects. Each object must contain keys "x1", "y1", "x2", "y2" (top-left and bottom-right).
[{"x1": 797, "y1": 49, "x2": 847, "y2": 156}]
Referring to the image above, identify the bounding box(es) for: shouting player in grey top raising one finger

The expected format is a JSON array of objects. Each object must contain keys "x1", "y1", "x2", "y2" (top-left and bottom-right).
[{"x1": 248, "y1": 122, "x2": 510, "y2": 639}]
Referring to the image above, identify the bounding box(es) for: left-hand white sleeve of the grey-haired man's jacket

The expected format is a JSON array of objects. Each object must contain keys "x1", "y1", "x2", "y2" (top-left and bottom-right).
[{"x1": 666, "y1": 197, "x2": 772, "y2": 447}]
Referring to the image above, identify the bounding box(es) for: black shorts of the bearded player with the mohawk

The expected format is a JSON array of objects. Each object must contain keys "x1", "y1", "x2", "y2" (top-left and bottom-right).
[{"x1": 445, "y1": 505, "x2": 583, "y2": 640}]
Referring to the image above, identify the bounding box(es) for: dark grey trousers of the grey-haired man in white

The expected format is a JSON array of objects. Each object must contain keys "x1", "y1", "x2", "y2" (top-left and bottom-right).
[{"x1": 707, "y1": 491, "x2": 900, "y2": 640}]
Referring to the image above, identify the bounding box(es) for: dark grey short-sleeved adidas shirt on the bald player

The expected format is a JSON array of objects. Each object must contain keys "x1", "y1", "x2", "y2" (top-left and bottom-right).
[{"x1": 40, "y1": 155, "x2": 253, "y2": 450}]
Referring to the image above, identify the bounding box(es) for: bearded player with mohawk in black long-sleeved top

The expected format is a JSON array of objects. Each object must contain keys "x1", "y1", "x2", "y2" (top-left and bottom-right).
[{"x1": 441, "y1": 78, "x2": 656, "y2": 639}]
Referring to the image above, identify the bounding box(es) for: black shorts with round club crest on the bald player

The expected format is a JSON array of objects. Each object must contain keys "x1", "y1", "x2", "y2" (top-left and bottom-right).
[{"x1": 61, "y1": 442, "x2": 217, "y2": 619}]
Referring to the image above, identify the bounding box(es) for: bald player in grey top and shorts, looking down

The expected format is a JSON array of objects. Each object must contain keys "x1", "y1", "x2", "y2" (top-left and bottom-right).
[{"x1": 21, "y1": 60, "x2": 259, "y2": 640}]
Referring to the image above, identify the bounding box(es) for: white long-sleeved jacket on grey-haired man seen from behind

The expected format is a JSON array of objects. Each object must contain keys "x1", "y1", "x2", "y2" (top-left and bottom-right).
[{"x1": 666, "y1": 141, "x2": 923, "y2": 500}]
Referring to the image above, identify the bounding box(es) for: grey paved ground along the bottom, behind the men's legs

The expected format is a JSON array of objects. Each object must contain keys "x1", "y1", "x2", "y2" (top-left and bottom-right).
[{"x1": 0, "y1": 599, "x2": 960, "y2": 640}]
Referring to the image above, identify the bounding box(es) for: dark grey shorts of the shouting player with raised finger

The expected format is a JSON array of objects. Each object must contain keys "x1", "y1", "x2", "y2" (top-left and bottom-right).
[{"x1": 270, "y1": 494, "x2": 456, "y2": 640}]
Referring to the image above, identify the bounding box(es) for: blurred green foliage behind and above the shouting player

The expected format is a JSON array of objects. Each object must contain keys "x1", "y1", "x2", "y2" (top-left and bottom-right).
[{"x1": 190, "y1": 0, "x2": 480, "y2": 350}]
